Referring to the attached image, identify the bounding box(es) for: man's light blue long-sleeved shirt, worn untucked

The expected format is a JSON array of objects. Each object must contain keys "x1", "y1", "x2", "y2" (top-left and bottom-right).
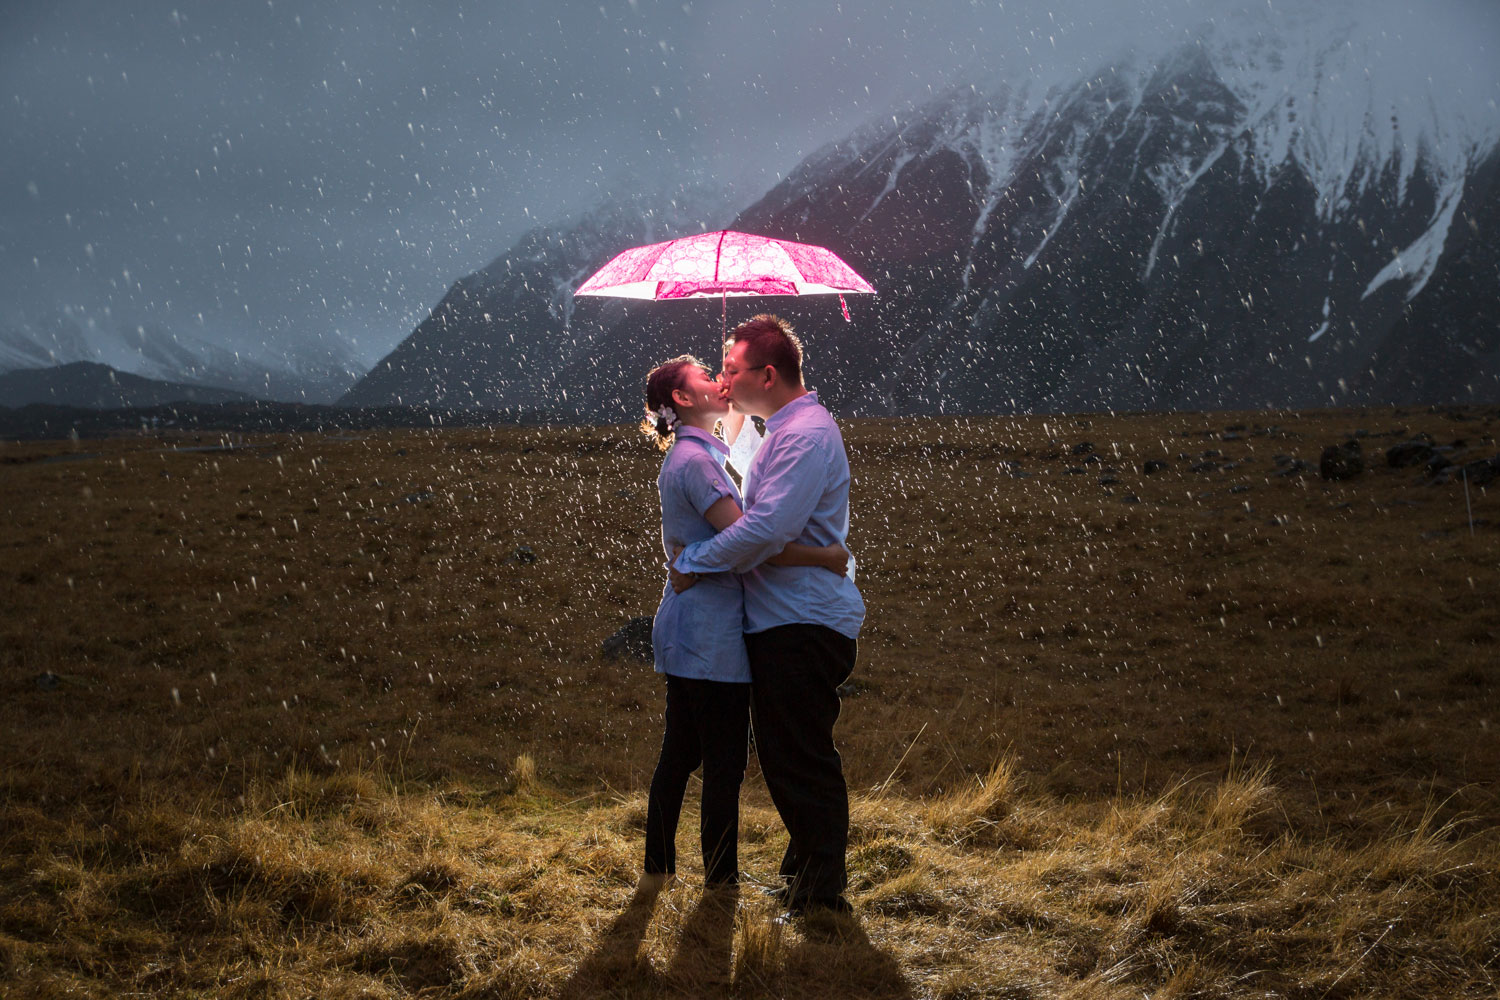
[{"x1": 677, "y1": 393, "x2": 864, "y2": 639}]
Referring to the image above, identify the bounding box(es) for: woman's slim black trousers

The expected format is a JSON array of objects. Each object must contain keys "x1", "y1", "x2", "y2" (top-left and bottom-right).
[{"x1": 645, "y1": 673, "x2": 750, "y2": 885}]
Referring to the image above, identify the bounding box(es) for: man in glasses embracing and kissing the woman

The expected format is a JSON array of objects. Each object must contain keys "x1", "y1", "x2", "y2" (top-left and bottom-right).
[{"x1": 672, "y1": 315, "x2": 864, "y2": 916}]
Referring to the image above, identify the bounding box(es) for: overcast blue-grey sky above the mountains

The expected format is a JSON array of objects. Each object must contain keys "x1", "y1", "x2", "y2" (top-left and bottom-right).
[{"x1": 0, "y1": 0, "x2": 1500, "y2": 363}]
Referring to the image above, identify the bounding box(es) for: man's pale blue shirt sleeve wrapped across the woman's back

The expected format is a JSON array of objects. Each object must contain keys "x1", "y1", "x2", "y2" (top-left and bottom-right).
[{"x1": 677, "y1": 435, "x2": 827, "y2": 573}]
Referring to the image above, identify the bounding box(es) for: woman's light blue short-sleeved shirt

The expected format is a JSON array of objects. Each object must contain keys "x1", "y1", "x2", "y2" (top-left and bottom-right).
[{"x1": 651, "y1": 427, "x2": 750, "y2": 684}]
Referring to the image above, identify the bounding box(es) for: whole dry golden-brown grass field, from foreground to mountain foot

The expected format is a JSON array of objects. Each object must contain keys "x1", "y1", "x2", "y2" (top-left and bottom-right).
[{"x1": 0, "y1": 408, "x2": 1500, "y2": 1000}]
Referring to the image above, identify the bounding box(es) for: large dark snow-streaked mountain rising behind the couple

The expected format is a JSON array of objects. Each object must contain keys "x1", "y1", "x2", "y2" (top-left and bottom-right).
[{"x1": 344, "y1": 4, "x2": 1500, "y2": 420}]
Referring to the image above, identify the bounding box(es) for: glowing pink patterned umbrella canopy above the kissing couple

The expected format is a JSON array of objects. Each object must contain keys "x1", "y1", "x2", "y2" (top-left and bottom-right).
[{"x1": 573, "y1": 229, "x2": 875, "y2": 329}]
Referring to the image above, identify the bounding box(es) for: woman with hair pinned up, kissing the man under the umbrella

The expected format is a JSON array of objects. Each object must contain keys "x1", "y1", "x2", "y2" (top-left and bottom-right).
[{"x1": 642, "y1": 355, "x2": 849, "y2": 888}]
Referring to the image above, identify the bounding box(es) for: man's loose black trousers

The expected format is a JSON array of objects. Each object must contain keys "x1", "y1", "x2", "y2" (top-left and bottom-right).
[{"x1": 746, "y1": 625, "x2": 858, "y2": 904}]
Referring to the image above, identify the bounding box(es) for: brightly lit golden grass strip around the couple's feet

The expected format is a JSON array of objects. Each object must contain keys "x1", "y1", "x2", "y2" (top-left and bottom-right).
[{"x1": 0, "y1": 757, "x2": 1500, "y2": 999}]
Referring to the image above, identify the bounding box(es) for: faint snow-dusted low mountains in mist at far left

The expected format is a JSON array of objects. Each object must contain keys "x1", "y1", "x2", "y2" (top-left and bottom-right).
[{"x1": 0, "y1": 313, "x2": 362, "y2": 405}]
